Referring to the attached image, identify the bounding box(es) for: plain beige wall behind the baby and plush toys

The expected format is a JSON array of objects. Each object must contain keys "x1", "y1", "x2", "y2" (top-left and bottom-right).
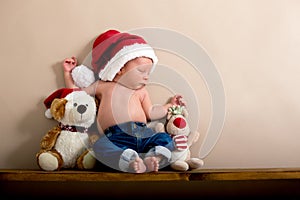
[{"x1": 0, "y1": 0, "x2": 300, "y2": 168}]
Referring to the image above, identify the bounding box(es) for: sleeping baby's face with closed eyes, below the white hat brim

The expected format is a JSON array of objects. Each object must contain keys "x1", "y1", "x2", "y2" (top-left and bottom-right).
[{"x1": 116, "y1": 57, "x2": 153, "y2": 90}]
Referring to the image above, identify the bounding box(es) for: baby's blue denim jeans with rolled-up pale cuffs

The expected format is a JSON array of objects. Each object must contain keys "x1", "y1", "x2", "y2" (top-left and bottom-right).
[{"x1": 93, "y1": 122, "x2": 175, "y2": 172}]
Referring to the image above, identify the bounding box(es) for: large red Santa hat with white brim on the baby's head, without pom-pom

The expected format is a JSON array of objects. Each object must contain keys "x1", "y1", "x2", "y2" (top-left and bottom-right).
[{"x1": 92, "y1": 30, "x2": 158, "y2": 81}]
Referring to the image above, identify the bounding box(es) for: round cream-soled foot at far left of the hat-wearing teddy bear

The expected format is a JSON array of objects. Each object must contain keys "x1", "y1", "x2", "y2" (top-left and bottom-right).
[{"x1": 37, "y1": 151, "x2": 61, "y2": 171}]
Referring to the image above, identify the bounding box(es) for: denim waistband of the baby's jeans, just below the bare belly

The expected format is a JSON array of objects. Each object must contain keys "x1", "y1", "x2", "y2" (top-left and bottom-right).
[{"x1": 104, "y1": 122, "x2": 147, "y2": 134}]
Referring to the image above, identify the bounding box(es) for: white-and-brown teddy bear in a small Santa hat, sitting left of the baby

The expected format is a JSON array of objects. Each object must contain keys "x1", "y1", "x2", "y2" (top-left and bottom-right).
[{"x1": 36, "y1": 88, "x2": 97, "y2": 171}]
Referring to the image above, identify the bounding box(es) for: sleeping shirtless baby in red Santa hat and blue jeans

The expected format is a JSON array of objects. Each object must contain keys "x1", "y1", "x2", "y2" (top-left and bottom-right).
[{"x1": 63, "y1": 30, "x2": 185, "y2": 173}]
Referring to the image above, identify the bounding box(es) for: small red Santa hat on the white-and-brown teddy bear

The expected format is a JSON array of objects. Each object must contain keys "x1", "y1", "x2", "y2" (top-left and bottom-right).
[{"x1": 44, "y1": 88, "x2": 81, "y2": 119}]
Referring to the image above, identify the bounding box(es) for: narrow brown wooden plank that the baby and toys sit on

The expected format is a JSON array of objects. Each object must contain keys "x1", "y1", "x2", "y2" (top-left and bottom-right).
[{"x1": 0, "y1": 168, "x2": 300, "y2": 182}]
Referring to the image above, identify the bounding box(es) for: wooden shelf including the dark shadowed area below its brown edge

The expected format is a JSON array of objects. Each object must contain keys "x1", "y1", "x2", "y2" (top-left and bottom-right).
[{"x1": 0, "y1": 168, "x2": 300, "y2": 198}]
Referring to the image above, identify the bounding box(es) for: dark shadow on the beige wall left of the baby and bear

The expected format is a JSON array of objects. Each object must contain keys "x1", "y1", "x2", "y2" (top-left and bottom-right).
[{"x1": 5, "y1": 39, "x2": 94, "y2": 169}]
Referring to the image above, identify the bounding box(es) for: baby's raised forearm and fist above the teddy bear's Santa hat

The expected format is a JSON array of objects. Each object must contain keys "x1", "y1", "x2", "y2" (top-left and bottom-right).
[{"x1": 63, "y1": 56, "x2": 77, "y2": 88}]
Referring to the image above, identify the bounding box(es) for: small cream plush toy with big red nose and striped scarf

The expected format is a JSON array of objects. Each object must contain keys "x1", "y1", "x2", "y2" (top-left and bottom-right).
[{"x1": 155, "y1": 105, "x2": 204, "y2": 171}]
